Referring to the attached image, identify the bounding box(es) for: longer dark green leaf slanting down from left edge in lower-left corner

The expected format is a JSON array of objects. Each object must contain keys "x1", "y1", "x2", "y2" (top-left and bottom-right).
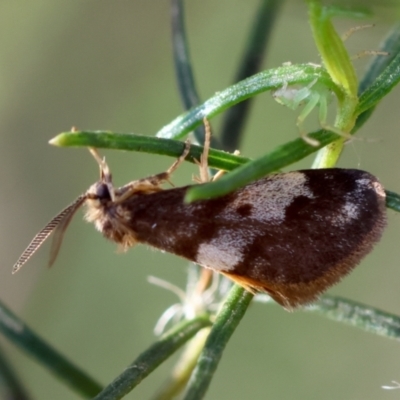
[{"x1": 0, "y1": 302, "x2": 102, "y2": 398}]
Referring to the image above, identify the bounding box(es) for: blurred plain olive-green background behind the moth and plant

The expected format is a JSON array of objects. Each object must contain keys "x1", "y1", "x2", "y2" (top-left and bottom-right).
[{"x1": 0, "y1": 0, "x2": 400, "y2": 400}]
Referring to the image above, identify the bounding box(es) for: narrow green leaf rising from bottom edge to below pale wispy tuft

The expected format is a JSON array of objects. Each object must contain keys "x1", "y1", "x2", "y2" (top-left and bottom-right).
[{"x1": 94, "y1": 316, "x2": 211, "y2": 400}]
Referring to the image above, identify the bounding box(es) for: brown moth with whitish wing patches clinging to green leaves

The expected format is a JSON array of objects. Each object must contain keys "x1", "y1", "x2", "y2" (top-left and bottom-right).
[{"x1": 13, "y1": 141, "x2": 386, "y2": 309}]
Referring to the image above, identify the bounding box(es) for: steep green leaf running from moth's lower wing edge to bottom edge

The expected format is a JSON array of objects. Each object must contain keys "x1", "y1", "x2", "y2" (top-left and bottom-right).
[{"x1": 184, "y1": 285, "x2": 253, "y2": 400}]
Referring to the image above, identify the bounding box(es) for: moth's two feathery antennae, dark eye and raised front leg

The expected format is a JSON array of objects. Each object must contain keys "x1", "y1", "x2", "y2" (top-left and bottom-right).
[{"x1": 12, "y1": 148, "x2": 111, "y2": 274}]
